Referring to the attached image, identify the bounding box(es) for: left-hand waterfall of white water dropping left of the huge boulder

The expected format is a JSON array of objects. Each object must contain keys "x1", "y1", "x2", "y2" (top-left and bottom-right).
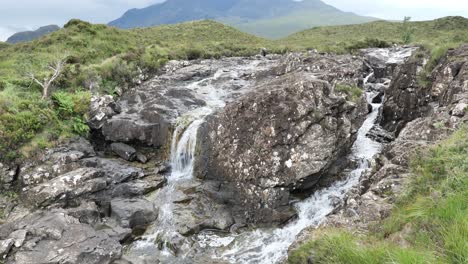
[{"x1": 126, "y1": 58, "x2": 266, "y2": 263}]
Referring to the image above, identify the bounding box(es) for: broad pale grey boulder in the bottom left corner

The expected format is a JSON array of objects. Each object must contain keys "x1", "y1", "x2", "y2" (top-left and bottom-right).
[{"x1": 0, "y1": 210, "x2": 122, "y2": 264}]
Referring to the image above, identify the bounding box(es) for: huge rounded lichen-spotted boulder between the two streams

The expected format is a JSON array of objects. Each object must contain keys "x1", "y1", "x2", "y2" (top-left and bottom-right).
[{"x1": 195, "y1": 52, "x2": 367, "y2": 223}]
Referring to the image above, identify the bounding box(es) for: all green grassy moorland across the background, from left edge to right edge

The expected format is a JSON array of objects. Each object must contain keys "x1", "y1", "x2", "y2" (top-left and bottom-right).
[{"x1": 0, "y1": 17, "x2": 468, "y2": 161}]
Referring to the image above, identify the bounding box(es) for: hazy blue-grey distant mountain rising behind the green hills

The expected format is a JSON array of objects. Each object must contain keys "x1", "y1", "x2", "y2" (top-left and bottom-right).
[{"x1": 109, "y1": 0, "x2": 376, "y2": 38}]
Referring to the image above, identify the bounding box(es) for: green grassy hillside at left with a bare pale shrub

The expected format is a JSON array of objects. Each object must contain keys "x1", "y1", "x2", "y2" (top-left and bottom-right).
[{"x1": 0, "y1": 20, "x2": 274, "y2": 161}]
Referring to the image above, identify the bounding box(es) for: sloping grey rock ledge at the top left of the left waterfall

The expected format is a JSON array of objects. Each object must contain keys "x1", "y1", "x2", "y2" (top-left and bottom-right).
[{"x1": 98, "y1": 58, "x2": 270, "y2": 147}]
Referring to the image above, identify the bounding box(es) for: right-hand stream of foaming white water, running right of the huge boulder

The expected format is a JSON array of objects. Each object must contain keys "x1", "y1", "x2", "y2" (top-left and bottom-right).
[{"x1": 198, "y1": 75, "x2": 381, "y2": 264}]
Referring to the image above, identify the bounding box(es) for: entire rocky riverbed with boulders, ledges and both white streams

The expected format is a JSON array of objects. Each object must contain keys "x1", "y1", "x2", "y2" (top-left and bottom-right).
[{"x1": 0, "y1": 46, "x2": 468, "y2": 264}]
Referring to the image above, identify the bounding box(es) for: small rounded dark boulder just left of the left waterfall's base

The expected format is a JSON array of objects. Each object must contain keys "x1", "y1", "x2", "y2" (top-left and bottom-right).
[{"x1": 111, "y1": 199, "x2": 157, "y2": 229}]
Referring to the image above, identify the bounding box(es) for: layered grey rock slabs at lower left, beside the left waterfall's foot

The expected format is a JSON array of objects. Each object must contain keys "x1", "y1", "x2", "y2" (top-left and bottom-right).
[{"x1": 0, "y1": 138, "x2": 165, "y2": 264}]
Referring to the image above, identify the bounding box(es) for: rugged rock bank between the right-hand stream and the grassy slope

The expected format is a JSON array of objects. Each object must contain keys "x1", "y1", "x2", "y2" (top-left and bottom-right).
[{"x1": 293, "y1": 45, "x2": 468, "y2": 258}]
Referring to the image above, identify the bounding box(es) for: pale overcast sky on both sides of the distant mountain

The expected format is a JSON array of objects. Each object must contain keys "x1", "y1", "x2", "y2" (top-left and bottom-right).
[{"x1": 0, "y1": 0, "x2": 468, "y2": 40}]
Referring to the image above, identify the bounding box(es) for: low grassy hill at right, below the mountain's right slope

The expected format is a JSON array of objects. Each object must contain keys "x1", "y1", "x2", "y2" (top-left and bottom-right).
[{"x1": 278, "y1": 17, "x2": 468, "y2": 53}]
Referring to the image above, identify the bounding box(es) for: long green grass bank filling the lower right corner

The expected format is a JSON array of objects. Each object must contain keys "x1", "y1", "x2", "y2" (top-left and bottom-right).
[{"x1": 289, "y1": 127, "x2": 468, "y2": 264}]
